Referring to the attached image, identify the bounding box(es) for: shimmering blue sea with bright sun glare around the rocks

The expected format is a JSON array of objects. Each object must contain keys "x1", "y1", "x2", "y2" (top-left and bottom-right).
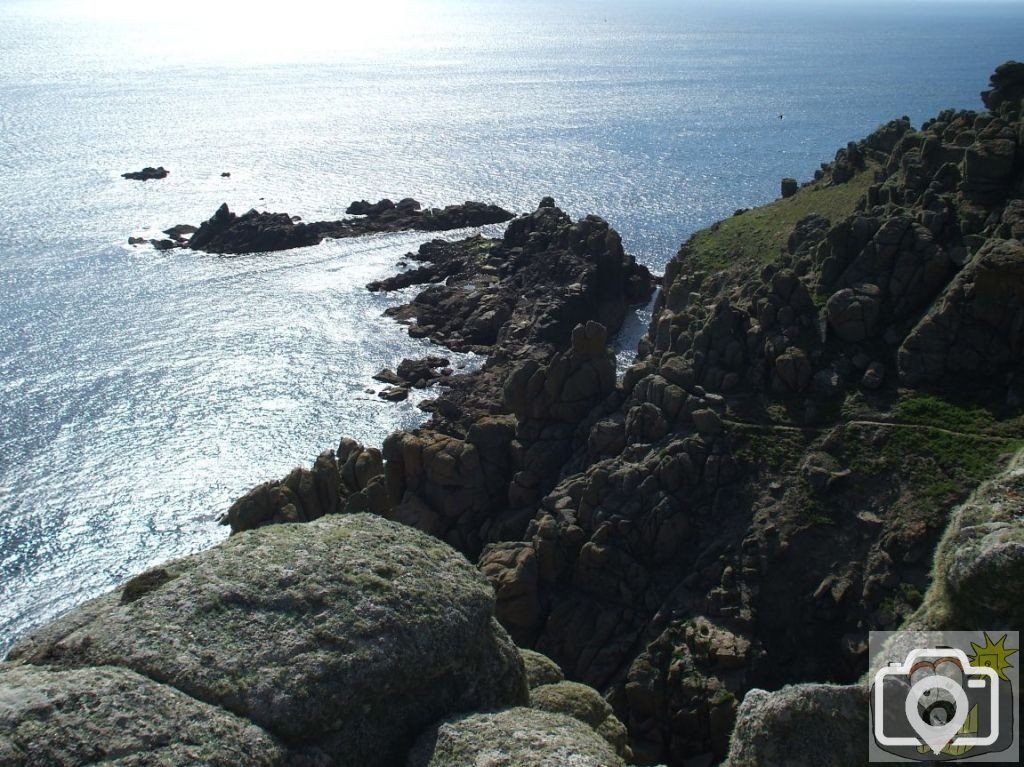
[{"x1": 0, "y1": 0, "x2": 1024, "y2": 655}]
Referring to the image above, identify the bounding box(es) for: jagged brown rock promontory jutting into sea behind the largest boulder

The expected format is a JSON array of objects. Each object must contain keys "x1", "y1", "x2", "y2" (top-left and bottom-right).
[{"x1": 225, "y1": 201, "x2": 653, "y2": 556}]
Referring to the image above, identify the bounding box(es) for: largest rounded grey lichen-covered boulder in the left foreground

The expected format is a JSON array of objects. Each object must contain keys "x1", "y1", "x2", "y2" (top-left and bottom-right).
[{"x1": 10, "y1": 515, "x2": 528, "y2": 765}]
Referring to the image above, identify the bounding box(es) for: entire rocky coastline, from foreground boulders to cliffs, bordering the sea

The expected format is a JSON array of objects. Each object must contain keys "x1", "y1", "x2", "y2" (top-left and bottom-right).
[{"x1": 8, "y1": 62, "x2": 1024, "y2": 767}]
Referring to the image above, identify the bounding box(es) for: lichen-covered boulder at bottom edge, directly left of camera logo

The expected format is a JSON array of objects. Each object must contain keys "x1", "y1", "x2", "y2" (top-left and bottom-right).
[{"x1": 726, "y1": 684, "x2": 868, "y2": 767}]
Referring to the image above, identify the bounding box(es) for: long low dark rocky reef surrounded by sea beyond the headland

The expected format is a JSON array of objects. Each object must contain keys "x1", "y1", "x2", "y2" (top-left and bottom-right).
[{"x1": 160, "y1": 199, "x2": 513, "y2": 253}]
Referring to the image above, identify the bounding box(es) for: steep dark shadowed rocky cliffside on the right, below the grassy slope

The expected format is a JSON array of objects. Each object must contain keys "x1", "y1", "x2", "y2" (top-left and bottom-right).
[{"x1": 479, "y1": 62, "x2": 1024, "y2": 763}]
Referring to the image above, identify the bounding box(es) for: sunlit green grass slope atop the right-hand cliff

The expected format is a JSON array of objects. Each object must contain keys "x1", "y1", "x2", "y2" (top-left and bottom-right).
[{"x1": 684, "y1": 167, "x2": 874, "y2": 270}]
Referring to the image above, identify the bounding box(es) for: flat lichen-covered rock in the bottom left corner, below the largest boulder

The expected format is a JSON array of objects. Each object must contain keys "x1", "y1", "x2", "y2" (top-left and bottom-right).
[{"x1": 0, "y1": 664, "x2": 288, "y2": 767}]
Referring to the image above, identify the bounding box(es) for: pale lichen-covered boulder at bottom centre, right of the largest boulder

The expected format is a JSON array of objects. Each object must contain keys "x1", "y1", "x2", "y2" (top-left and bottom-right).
[{"x1": 407, "y1": 709, "x2": 626, "y2": 767}]
